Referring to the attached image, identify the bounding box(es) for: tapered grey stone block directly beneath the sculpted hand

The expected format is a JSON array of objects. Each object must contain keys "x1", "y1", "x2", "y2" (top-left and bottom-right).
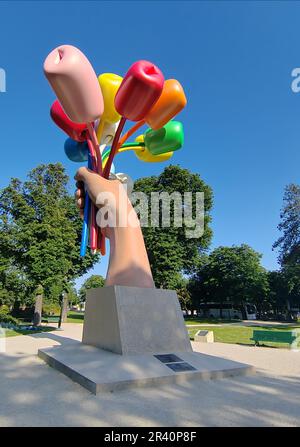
[{"x1": 82, "y1": 286, "x2": 192, "y2": 355}]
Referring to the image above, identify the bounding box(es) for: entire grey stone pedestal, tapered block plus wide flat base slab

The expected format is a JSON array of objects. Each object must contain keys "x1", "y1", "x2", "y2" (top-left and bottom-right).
[{"x1": 38, "y1": 286, "x2": 253, "y2": 394}]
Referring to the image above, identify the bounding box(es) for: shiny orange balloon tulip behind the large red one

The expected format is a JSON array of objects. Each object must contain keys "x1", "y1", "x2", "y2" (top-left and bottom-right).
[{"x1": 145, "y1": 79, "x2": 187, "y2": 130}]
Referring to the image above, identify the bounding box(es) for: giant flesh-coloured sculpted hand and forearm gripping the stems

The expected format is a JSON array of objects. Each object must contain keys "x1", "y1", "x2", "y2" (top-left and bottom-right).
[{"x1": 75, "y1": 167, "x2": 155, "y2": 288}]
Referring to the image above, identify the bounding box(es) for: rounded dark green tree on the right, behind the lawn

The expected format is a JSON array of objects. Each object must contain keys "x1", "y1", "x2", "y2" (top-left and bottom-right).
[{"x1": 190, "y1": 244, "x2": 268, "y2": 315}]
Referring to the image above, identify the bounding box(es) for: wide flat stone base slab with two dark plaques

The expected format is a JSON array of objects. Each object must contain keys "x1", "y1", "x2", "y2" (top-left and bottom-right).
[{"x1": 38, "y1": 341, "x2": 254, "y2": 394}]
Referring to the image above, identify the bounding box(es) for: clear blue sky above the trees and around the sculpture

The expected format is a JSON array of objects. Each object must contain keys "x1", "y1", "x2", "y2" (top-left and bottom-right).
[{"x1": 0, "y1": 1, "x2": 300, "y2": 288}]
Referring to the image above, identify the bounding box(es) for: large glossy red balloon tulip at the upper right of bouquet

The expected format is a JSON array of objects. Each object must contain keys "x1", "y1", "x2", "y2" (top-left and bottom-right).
[{"x1": 115, "y1": 61, "x2": 164, "y2": 121}]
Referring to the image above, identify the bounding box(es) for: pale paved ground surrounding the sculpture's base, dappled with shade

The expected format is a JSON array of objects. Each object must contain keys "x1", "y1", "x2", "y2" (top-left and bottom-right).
[{"x1": 0, "y1": 323, "x2": 300, "y2": 427}]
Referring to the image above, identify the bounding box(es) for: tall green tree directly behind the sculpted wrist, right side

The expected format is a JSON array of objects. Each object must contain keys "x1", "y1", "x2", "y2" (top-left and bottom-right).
[{"x1": 134, "y1": 165, "x2": 213, "y2": 288}]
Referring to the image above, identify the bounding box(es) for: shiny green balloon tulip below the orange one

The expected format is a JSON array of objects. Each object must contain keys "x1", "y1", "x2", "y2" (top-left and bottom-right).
[{"x1": 144, "y1": 121, "x2": 184, "y2": 155}]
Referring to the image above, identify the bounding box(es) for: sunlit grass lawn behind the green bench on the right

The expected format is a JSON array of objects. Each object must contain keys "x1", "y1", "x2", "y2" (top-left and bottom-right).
[{"x1": 188, "y1": 325, "x2": 299, "y2": 348}]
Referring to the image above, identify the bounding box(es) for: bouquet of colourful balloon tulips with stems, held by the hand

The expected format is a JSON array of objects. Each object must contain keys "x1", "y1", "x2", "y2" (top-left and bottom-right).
[{"x1": 44, "y1": 45, "x2": 186, "y2": 256}]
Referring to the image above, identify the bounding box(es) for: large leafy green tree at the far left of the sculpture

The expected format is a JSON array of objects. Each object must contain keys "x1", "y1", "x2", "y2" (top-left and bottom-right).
[{"x1": 0, "y1": 163, "x2": 99, "y2": 324}]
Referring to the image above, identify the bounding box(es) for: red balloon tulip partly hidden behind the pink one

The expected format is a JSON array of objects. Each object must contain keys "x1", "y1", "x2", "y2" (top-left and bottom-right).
[{"x1": 50, "y1": 99, "x2": 87, "y2": 142}]
